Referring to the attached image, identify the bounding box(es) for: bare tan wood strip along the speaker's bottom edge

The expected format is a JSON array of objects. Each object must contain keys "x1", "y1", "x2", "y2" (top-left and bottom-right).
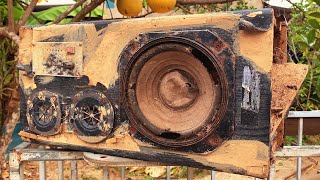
[{"x1": 20, "y1": 132, "x2": 269, "y2": 178}]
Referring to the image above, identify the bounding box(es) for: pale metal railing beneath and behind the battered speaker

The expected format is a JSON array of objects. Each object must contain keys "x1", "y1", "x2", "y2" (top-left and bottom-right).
[{"x1": 9, "y1": 111, "x2": 320, "y2": 180}]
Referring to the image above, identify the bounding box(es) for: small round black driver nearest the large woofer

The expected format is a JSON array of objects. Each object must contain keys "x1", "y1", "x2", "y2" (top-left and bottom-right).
[{"x1": 71, "y1": 89, "x2": 114, "y2": 143}]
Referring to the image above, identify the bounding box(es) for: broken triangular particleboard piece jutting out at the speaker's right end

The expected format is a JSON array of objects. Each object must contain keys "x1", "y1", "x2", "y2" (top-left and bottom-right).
[{"x1": 270, "y1": 63, "x2": 308, "y2": 152}]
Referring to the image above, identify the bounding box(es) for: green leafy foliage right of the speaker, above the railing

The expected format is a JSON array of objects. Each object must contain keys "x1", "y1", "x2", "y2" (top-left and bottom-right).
[{"x1": 288, "y1": 0, "x2": 320, "y2": 111}]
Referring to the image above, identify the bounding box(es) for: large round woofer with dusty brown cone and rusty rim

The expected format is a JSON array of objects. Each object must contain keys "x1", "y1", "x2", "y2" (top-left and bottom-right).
[{"x1": 126, "y1": 38, "x2": 227, "y2": 147}]
